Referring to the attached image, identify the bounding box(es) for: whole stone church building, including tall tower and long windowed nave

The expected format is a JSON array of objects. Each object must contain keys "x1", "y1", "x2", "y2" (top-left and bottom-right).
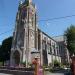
[{"x1": 10, "y1": 0, "x2": 69, "y2": 66}]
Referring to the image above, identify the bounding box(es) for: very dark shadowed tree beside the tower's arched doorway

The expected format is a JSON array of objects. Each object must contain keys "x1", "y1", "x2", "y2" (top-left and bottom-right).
[{"x1": 0, "y1": 37, "x2": 12, "y2": 62}]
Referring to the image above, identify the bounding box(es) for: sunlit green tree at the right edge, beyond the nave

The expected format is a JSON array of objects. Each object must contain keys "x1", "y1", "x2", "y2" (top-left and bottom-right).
[{"x1": 65, "y1": 25, "x2": 75, "y2": 56}]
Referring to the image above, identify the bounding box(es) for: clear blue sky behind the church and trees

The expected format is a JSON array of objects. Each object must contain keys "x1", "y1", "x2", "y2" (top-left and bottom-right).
[{"x1": 0, "y1": 0, "x2": 75, "y2": 44}]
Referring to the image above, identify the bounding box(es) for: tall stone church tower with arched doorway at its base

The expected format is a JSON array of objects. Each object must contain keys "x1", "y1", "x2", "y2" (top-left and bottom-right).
[{"x1": 10, "y1": 0, "x2": 38, "y2": 66}]
